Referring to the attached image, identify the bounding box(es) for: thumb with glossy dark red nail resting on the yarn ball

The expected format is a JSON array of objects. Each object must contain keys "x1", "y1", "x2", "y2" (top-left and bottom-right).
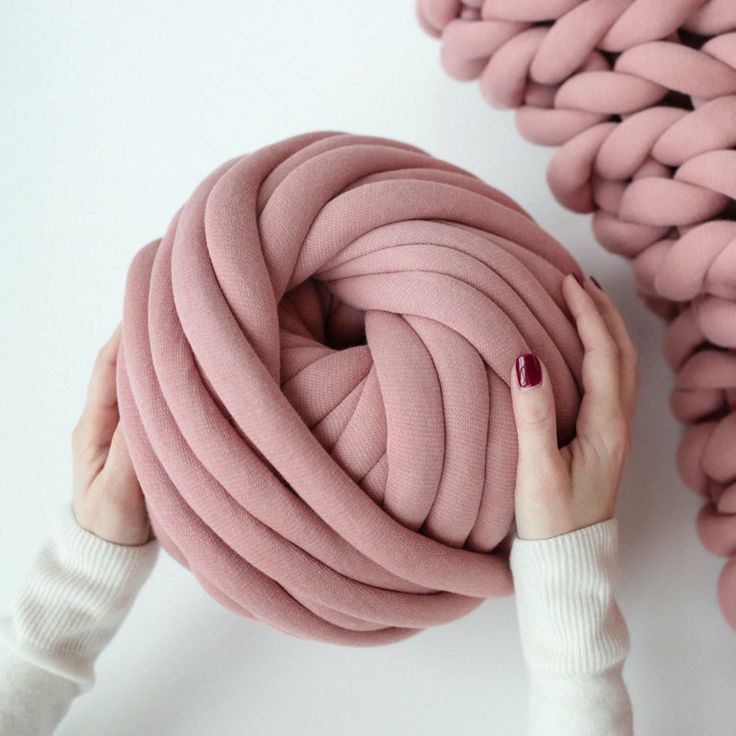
[{"x1": 510, "y1": 354, "x2": 559, "y2": 467}]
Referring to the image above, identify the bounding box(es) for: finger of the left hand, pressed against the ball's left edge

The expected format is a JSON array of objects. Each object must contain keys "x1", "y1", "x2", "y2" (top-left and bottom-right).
[{"x1": 75, "y1": 325, "x2": 122, "y2": 449}]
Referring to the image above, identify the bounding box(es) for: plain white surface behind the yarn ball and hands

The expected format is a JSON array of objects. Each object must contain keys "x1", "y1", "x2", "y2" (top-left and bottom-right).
[{"x1": 0, "y1": 0, "x2": 736, "y2": 736}]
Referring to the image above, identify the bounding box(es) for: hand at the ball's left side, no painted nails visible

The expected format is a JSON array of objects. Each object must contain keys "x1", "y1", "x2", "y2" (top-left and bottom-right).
[{"x1": 72, "y1": 325, "x2": 151, "y2": 545}]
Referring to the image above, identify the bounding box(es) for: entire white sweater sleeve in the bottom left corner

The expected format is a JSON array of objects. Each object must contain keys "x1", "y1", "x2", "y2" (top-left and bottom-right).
[{"x1": 0, "y1": 504, "x2": 159, "y2": 736}]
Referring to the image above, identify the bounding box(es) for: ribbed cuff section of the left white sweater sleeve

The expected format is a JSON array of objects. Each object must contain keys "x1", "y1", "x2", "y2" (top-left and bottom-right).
[{"x1": 0, "y1": 504, "x2": 159, "y2": 690}]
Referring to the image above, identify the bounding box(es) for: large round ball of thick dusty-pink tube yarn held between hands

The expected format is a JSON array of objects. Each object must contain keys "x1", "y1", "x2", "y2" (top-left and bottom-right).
[{"x1": 118, "y1": 133, "x2": 582, "y2": 645}]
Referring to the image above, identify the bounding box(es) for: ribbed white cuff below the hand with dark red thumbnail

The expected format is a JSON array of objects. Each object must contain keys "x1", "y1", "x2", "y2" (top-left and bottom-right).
[{"x1": 511, "y1": 518, "x2": 629, "y2": 676}]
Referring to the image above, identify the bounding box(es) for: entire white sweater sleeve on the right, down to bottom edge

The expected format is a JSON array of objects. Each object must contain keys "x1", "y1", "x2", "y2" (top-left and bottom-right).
[{"x1": 511, "y1": 518, "x2": 633, "y2": 736}]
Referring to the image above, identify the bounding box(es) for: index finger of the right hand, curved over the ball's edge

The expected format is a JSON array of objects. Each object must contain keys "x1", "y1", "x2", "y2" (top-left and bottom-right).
[{"x1": 562, "y1": 274, "x2": 621, "y2": 431}]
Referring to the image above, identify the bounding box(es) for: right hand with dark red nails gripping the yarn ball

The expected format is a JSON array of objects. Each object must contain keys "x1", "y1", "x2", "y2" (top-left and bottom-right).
[{"x1": 511, "y1": 274, "x2": 639, "y2": 539}]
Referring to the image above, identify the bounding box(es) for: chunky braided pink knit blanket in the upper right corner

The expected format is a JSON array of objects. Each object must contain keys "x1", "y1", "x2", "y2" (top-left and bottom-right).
[{"x1": 418, "y1": 0, "x2": 736, "y2": 628}]
